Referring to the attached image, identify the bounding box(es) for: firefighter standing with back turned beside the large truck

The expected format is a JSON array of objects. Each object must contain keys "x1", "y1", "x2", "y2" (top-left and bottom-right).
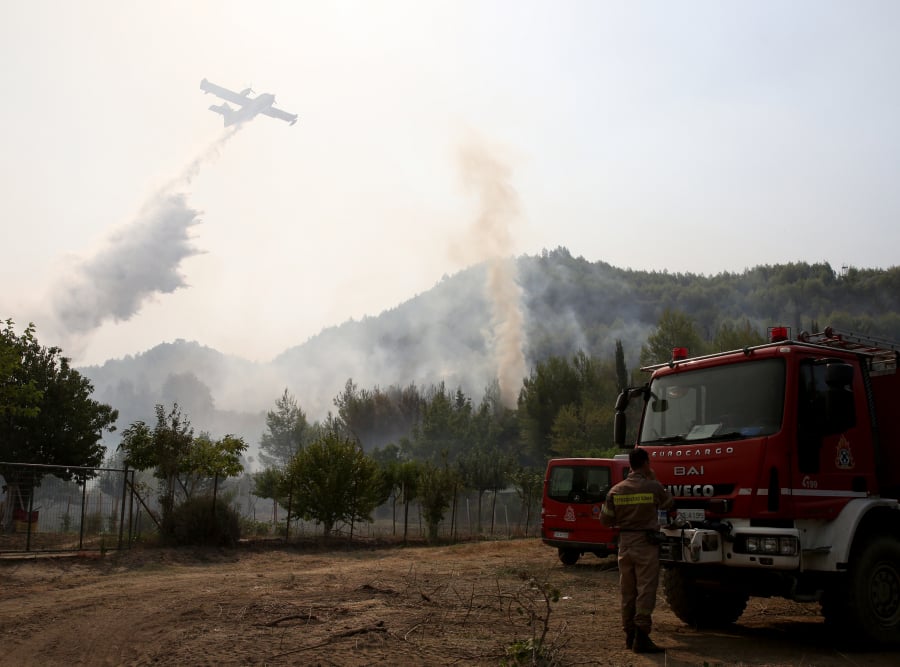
[{"x1": 600, "y1": 447, "x2": 673, "y2": 653}]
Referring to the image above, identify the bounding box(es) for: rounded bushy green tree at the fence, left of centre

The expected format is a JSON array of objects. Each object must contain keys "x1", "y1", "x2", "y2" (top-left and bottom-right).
[{"x1": 285, "y1": 433, "x2": 386, "y2": 536}]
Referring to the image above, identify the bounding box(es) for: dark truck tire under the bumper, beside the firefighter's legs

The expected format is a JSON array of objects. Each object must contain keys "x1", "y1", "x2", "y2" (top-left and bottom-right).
[{"x1": 663, "y1": 567, "x2": 750, "y2": 628}]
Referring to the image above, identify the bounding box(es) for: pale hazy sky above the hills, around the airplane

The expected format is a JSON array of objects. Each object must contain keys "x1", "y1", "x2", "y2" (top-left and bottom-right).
[{"x1": 0, "y1": 0, "x2": 900, "y2": 364}]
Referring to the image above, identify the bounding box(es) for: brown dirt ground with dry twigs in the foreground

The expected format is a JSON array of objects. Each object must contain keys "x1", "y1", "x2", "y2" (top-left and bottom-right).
[{"x1": 0, "y1": 539, "x2": 900, "y2": 667}]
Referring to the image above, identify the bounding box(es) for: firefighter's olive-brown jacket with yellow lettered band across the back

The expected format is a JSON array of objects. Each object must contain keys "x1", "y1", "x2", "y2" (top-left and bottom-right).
[{"x1": 600, "y1": 472, "x2": 674, "y2": 544}]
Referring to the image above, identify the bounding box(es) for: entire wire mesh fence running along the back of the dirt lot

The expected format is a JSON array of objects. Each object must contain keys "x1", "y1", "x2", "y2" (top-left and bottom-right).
[{"x1": 0, "y1": 462, "x2": 540, "y2": 554}]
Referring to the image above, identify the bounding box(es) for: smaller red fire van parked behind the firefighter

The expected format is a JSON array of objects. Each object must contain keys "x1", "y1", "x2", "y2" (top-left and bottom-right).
[{"x1": 541, "y1": 454, "x2": 629, "y2": 565}]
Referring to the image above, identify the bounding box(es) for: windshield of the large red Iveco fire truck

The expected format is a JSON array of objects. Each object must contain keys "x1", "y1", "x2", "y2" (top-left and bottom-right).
[{"x1": 638, "y1": 359, "x2": 785, "y2": 445}]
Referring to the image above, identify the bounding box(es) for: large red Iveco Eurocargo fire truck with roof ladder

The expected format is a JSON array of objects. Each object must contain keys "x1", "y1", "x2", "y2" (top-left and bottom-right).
[{"x1": 615, "y1": 327, "x2": 900, "y2": 643}]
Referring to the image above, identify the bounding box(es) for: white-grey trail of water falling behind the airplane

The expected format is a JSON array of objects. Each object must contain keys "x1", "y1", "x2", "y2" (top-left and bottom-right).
[{"x1": 53, "y1": 125, "x2": 241, "y2": 334}]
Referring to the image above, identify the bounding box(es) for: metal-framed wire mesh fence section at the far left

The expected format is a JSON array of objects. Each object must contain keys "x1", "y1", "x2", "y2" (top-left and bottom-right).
[{"x1": 0, "y1": 462, "x2": 140, "y2": 553}]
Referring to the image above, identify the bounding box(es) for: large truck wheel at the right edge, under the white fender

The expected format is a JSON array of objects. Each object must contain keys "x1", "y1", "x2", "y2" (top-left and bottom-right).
[{"x1": 844, "y1": 537, "x2": 900, "y2": 644}]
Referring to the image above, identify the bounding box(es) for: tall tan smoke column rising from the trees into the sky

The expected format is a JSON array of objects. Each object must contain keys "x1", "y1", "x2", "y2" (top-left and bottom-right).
[{"x1": 459, "y1": 135, "x2": 525, "y2": 407}]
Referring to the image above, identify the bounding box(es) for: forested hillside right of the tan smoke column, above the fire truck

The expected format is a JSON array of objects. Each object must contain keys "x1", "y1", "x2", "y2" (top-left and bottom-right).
[{"x1": 519, "y1": 248, "x2": 900, "y2": 361}]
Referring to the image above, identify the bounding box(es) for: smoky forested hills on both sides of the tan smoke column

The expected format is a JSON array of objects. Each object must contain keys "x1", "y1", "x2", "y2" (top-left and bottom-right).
[{"x1": 83, "y1": 248, "x2": 900, "y2": 468}]
